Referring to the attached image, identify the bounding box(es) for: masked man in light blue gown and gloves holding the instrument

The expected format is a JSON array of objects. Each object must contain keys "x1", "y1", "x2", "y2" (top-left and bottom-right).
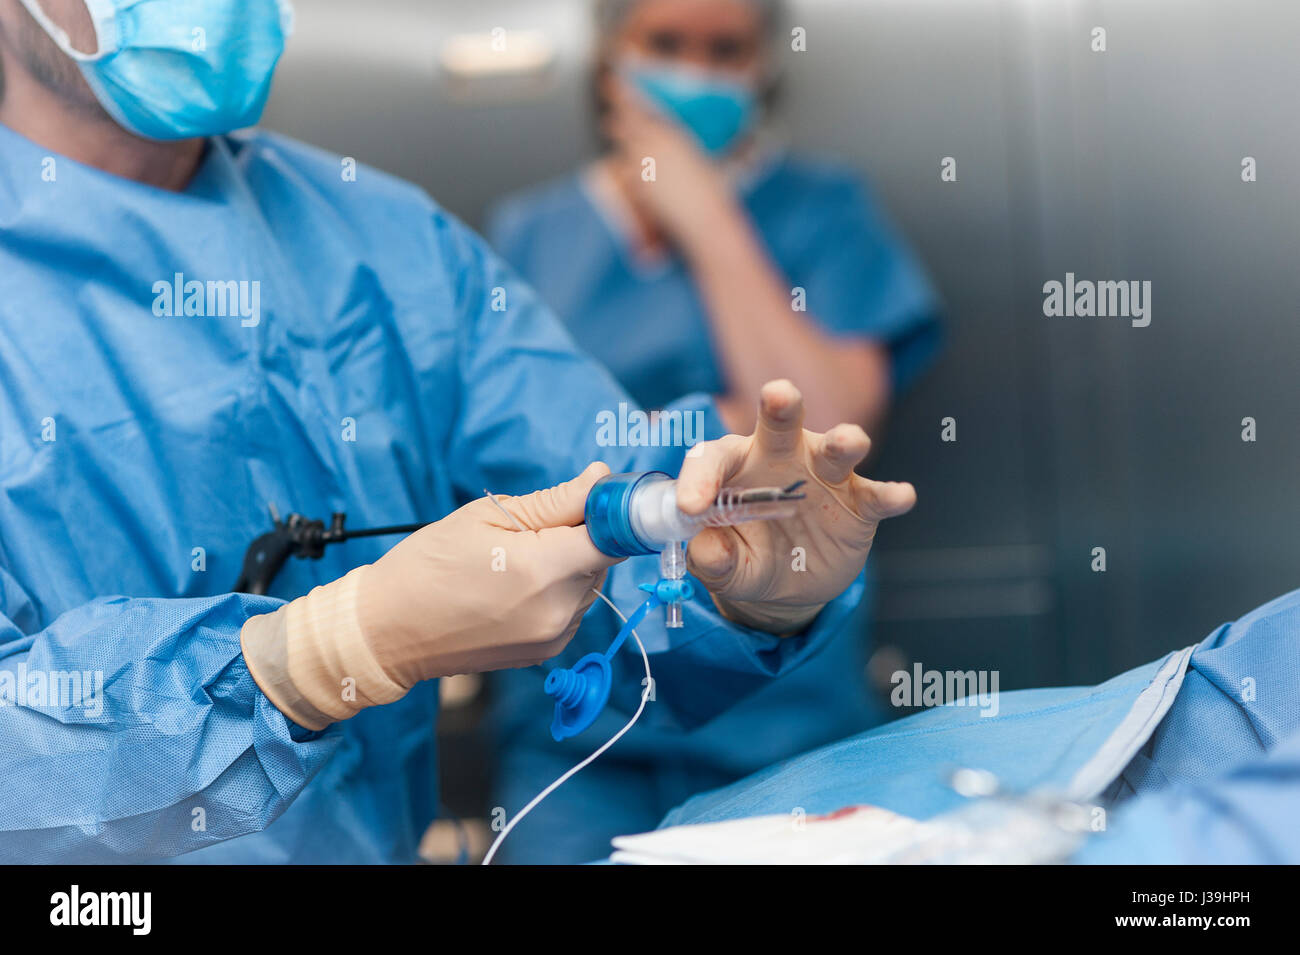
[{"x1": 0, "y1": 0, "x2": 914, "y2": 863}]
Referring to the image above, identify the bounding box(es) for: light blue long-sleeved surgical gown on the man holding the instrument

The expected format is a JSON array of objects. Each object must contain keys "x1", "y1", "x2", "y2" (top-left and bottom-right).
[{"x1": 0, "y1": 126, "x2": 863, "y2": 863}]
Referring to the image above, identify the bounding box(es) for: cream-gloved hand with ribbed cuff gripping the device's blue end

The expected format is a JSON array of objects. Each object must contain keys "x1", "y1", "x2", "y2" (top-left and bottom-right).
[{"x1": 241, "y1": 464, "x2": 618, "y2": 729}]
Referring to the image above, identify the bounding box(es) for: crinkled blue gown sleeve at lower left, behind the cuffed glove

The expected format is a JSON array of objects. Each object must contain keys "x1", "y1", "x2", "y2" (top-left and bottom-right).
[{"x1": 0, "y1": 569, "x2": 337, "y2": 863}]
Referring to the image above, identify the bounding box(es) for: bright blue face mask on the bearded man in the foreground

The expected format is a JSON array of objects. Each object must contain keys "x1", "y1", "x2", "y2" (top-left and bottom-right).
[{"x1": 22, "y1": 0, "x2": 293, "y2": 139}]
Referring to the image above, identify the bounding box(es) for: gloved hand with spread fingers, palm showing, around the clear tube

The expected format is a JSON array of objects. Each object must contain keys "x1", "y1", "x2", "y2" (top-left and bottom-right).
[{"x1": 677, "y1": 381, "x2": 917, "y2": 634}]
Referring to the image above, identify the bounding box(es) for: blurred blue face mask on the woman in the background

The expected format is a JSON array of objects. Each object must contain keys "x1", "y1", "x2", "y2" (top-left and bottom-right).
[{"x1": 623, "y1": 62, "x2": 758, "y2": 156}]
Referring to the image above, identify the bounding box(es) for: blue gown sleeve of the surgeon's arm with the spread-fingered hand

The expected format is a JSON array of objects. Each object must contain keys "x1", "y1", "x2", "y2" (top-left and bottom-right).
[{"x1": 437, "y1": 213, "x2": 865, "y2": 728}]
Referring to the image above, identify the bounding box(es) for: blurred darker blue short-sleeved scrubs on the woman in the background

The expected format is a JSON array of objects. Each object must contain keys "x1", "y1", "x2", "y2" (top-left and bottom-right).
[{"x1": 489, "y1": 156, "x2": 939, "y2": 861}]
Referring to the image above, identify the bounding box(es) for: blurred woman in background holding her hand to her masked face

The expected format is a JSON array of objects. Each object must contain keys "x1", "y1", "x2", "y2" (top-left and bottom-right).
[{"x1": 489, "y1": 0, "x2": 939, "y2": 861}]
